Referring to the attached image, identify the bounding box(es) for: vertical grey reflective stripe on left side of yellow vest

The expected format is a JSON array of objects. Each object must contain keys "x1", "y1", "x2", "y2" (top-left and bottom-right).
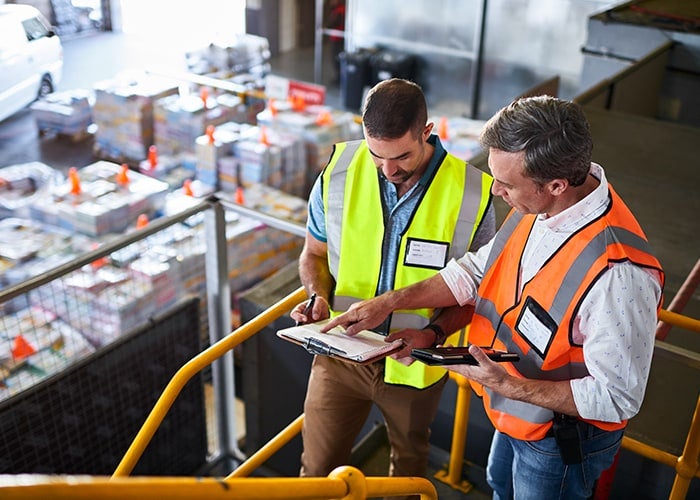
[{"x1": 326, "y1": 141, "x2": 362, "y2": 280}]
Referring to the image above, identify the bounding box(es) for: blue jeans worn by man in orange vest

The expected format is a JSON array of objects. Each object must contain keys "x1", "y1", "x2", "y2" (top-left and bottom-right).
[{"x1": 486, "y1": 424, "x2": 624, "y2": 500}]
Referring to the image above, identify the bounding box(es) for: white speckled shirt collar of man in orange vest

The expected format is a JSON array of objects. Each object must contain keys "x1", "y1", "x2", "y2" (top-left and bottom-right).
[{"x1": 537, "y1": 163, "x2": 609, "y2": 232}]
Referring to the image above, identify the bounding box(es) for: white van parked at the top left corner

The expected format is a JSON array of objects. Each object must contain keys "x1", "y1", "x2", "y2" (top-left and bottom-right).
[{"x1": 0, "y1": 4, "x2": 63, "y2": 121}]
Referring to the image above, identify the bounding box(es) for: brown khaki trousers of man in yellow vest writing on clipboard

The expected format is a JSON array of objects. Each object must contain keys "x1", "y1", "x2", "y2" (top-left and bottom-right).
[{"x1": 301, "y1": 356, "x2": 447, "y2": 477}]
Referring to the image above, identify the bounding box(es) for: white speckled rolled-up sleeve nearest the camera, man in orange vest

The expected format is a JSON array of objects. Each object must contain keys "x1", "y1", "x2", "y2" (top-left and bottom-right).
[{"x1": 571, "y1": 263, "x2": 661, "y2": 422}]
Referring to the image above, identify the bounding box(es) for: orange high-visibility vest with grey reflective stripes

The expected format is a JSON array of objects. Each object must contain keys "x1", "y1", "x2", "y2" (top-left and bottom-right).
[{"x1": 469, "y1": 187, "x2": 664, "y2": 441}]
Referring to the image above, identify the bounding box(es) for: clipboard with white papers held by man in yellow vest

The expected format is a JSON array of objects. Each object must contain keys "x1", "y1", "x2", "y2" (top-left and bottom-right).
[{"x1": 277, "y1": 320, "x2": 403, "y2": 364}]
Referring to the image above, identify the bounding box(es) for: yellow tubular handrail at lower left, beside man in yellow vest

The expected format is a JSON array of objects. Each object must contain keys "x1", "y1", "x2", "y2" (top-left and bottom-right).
[{"x1": 108, "y1": 287, "x2": 437, "y2": 499}]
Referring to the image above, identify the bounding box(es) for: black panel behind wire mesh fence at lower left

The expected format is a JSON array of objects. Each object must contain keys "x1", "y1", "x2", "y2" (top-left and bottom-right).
[{"x1": 0, "y1": 298, "x2": 207, "y2": 475}]
